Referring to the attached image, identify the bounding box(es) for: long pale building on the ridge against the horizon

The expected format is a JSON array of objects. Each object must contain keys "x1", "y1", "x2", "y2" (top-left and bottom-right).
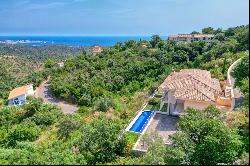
[{"x1": 168, "y1": 34, "x2": 214, "y2": 43}]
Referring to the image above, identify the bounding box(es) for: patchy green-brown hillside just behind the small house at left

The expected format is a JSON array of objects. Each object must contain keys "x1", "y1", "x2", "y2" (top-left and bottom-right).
[{"x1": 0, "y1": 55, "x2": 46, "y2": 100}]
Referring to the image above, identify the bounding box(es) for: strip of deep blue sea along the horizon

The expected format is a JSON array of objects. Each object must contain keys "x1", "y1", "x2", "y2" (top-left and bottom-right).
[{"x1": 0, "y1": 36, "x2": 167, "y2": 46}]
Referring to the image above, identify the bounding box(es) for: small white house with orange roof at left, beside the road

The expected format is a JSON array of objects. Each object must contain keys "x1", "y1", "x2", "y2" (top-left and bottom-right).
[{"x1": 8, "y1": 84, "x2": 35, "y2": 105}]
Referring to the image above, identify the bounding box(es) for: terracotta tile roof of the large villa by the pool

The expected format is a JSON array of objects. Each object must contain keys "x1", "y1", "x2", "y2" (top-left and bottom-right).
[{"x1": 159, "y1": 69, "x2": 222, "y2": 102}]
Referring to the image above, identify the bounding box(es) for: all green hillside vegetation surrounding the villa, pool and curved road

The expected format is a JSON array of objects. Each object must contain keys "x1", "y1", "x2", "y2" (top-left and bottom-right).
[{"x1": 0, "y1": 25, "x2": 249, "y2": 165}]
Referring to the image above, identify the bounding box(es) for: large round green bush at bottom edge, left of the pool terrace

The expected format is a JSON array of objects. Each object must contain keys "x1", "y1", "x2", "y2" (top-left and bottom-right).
[{"x1": 76, "y1": 117, "x2": 127, "y2": 165}]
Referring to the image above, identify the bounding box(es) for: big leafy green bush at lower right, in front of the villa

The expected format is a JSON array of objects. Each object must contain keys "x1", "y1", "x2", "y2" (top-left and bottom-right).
[{"x1": 166, "y1": 107, "x2": 242, "y2": 165}]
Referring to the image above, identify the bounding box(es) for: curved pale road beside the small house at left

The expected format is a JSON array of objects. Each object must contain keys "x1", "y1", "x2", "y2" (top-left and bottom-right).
[{"x1": 35, "y1": 78, "x2": 78, "y2": 113}]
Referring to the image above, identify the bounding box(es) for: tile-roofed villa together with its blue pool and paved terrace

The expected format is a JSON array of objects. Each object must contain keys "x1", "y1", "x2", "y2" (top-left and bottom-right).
[{"x1": 131, "y1": 69, "x2": 234, "y2": 152}]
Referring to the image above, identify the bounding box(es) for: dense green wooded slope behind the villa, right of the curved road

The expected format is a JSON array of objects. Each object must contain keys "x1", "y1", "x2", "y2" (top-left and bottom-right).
[{"x1": 50, "y1": 26, "x2": 249, "y2": 107}]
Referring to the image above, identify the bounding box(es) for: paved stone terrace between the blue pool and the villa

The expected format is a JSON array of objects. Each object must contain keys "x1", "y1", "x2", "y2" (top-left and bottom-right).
[{"x1": 133, "y1": 112, "x2": 179, "y2": 151}]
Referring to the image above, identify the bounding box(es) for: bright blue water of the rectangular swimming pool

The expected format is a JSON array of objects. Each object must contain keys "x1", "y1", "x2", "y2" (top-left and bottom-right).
[{"x1": 129, "y1": 111, "x2": 153, "y2": 133}]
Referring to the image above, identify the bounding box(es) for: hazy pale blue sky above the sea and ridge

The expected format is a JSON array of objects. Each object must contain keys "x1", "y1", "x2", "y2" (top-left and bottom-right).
[{"x1": 0, "y1": 0, "x2": 249, "y2": 35}]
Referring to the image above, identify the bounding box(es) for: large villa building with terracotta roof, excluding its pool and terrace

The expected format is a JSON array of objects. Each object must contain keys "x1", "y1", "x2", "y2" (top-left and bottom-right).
[{"x1": 158, "y1": 69, "x2": 222, "y2": 115}]
